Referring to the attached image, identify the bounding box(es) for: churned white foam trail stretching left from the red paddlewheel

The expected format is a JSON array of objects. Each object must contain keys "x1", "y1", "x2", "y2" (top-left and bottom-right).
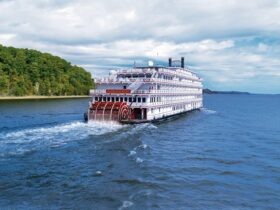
[{"x1": 0, "y1": 121, "x2": 124, "y2": 156}]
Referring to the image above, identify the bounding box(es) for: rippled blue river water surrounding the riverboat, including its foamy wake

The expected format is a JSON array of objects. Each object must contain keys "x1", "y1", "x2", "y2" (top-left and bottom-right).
[{"x1": 0, "y1": 95, "x2": 280, "y2": 210}]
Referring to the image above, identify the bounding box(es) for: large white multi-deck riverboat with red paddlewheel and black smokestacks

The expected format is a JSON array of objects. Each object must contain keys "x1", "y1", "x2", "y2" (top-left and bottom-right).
[{"x1": 84, "y1": 57, "x2": 203, "y2": 123}]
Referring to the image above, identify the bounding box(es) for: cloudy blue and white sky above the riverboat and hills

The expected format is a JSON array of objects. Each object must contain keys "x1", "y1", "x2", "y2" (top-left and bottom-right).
[{"x1": 0, "y1": 0, "x2": 280, "y2": 93}]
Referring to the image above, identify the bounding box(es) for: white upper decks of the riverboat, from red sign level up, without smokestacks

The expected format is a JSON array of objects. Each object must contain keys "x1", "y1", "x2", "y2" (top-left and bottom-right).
[{"x1": 90, "y1": 57, "x2": 202, "y2": 95}]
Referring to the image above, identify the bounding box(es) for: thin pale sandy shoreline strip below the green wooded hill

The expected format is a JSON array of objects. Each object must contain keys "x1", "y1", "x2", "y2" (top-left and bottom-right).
[{"x1": 0, "y1": 95, "x2": 90, "y2": 101}]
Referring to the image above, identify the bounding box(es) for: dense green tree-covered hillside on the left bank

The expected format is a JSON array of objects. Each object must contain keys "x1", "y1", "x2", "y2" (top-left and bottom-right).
[{"x1": 0, "y1": 45, "x2": 93, "y2": 96}]
